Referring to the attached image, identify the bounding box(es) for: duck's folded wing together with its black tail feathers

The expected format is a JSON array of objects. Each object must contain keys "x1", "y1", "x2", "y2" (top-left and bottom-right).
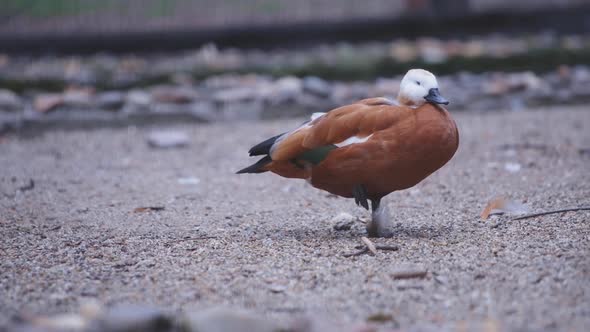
[{"x1": 238, "y1": 98, "x2": 408, "y2": 178}]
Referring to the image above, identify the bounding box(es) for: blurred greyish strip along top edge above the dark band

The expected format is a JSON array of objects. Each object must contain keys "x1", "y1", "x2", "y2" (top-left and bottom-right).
[{"x1": 0, "y1": 0, "x2": 590, "y2": 51}]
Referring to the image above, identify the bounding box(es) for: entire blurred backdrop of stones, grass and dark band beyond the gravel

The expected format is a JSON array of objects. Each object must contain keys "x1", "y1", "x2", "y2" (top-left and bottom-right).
[{"x1": 0, "y1": 0, "x2": 590, "y2": 130}]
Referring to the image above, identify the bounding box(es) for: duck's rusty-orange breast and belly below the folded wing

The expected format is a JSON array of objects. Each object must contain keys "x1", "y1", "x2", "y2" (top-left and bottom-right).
[{"x1": 310, "y1": 104, "x2": 459, "y2": 198}]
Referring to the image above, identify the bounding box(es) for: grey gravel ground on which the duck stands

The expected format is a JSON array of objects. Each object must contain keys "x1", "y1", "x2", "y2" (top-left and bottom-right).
[{"x1": 0, "y1": 108, "x2": 590, "y2": 331}]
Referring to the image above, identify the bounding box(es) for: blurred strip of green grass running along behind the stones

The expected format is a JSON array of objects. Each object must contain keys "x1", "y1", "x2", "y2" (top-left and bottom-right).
[{"x1": 0, "y1": 47, "x2": 590, "y2": 93}]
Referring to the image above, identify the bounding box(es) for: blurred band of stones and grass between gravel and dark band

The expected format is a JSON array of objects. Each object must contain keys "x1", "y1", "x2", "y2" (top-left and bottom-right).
[{"x1": 0, "y1": 33, "x2": 590, "y2": 134}]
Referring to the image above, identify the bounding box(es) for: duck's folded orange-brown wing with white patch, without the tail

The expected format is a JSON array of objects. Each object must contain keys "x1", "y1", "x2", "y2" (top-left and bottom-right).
[{"x1": 269, "y1": 98, "x2": 406, "y2": 164}]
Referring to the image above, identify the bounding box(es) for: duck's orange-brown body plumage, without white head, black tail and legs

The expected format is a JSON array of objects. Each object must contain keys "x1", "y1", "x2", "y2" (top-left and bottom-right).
[{"x1": 263, "y1": 98, "x2": 459, "y2": 199}]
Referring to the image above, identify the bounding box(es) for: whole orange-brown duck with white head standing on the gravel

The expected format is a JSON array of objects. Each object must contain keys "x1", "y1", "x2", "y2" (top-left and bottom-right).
[{"x1": 238, "y1": 69, "x2": 459, "y2": 237}]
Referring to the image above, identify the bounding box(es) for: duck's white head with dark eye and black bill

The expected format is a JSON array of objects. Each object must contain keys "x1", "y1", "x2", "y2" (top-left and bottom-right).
[{"x1": 397, "y1": 69, "x2": 449, "y2": 107}]
